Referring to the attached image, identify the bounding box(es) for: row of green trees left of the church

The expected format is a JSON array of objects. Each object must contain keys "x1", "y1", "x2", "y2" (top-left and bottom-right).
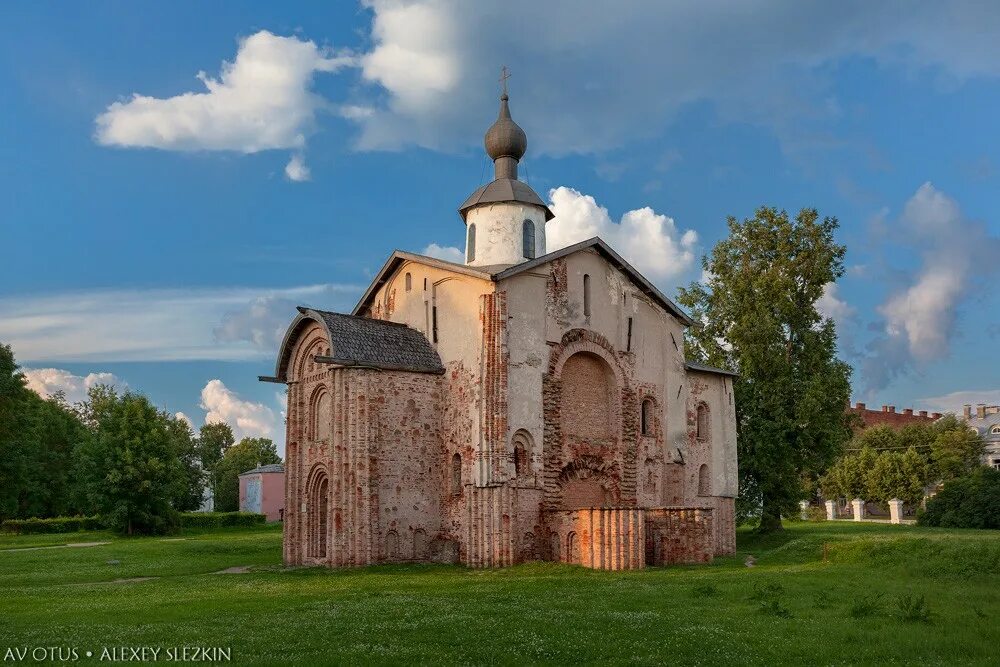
[{"x1": 0, "y1": 345, "x2": 281, "y2": 534}]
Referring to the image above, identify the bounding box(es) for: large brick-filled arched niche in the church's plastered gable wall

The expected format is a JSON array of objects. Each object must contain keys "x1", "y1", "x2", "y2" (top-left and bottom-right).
[{"x1": 559, "y1": 351, "x2": 620, "y2": 444}]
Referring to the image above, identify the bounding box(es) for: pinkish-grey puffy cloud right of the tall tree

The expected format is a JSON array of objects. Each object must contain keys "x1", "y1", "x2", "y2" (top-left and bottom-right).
[{"x1": 863, "y1": 183, "x2": 1000, "y2": 390}]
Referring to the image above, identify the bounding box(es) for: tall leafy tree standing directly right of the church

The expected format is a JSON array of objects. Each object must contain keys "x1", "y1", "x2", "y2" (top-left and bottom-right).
[{"x1": 679, "y1": 207, "x2": 850, "y2": 532}]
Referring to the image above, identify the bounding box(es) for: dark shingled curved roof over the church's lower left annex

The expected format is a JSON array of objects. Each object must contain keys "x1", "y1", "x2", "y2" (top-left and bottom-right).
[{"x1": 261, "y1": 306, "x2": 444, "y2": 382}]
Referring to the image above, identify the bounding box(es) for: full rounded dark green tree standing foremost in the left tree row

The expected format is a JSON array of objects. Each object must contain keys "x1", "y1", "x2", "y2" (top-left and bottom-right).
[{"x1": 78, "y1": 386, "x2": 185, "y2": 535}]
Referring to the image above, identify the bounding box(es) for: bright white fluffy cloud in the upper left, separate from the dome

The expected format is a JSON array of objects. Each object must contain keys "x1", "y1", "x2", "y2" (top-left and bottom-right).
[{"x1": 96, "y1": 30, "x2": 356, "y2": 158}]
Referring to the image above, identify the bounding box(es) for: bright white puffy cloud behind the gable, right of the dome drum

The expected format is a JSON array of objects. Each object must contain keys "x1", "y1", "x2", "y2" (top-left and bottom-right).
[{"x1": 545, "y1": 187, "x2": 698, "y2": 281}]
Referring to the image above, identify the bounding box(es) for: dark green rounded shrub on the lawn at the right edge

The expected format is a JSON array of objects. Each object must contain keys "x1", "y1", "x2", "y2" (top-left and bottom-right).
[{"x1": 917, "y1": 466, "x2": 1000, "y2": 529}]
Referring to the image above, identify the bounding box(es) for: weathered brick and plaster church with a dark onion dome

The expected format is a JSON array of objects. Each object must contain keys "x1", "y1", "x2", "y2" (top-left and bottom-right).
[{"x1": 261, "y1": 86, "x2": 737, "y2": 569}]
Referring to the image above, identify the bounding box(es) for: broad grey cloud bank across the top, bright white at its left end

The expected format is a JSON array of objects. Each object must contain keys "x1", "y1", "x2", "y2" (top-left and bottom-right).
[{"x1": 350, "y1": 0, "x2": 1000, "y2": 154}]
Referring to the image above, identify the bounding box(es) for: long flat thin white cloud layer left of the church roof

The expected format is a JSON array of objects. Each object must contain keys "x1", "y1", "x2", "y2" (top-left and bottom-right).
[{"x1": 0, "y1": 284, "x2": 361, "y2": 362}]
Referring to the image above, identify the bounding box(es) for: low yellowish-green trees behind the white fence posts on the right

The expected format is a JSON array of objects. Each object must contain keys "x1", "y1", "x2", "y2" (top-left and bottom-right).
[{"x1": 820, "y1": 415, "x2": 983, "y2": 505}]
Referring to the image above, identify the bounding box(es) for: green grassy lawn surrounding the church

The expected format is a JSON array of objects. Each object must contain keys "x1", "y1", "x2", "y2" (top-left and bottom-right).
[{"x1": 0, "y1": 522, "x2": 1000, "y2": 665}]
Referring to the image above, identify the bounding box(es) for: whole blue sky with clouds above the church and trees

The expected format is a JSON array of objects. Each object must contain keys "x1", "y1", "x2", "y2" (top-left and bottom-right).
[{"x1": 0, "y1": 0, "x2": 1000, "y2": 454}]
